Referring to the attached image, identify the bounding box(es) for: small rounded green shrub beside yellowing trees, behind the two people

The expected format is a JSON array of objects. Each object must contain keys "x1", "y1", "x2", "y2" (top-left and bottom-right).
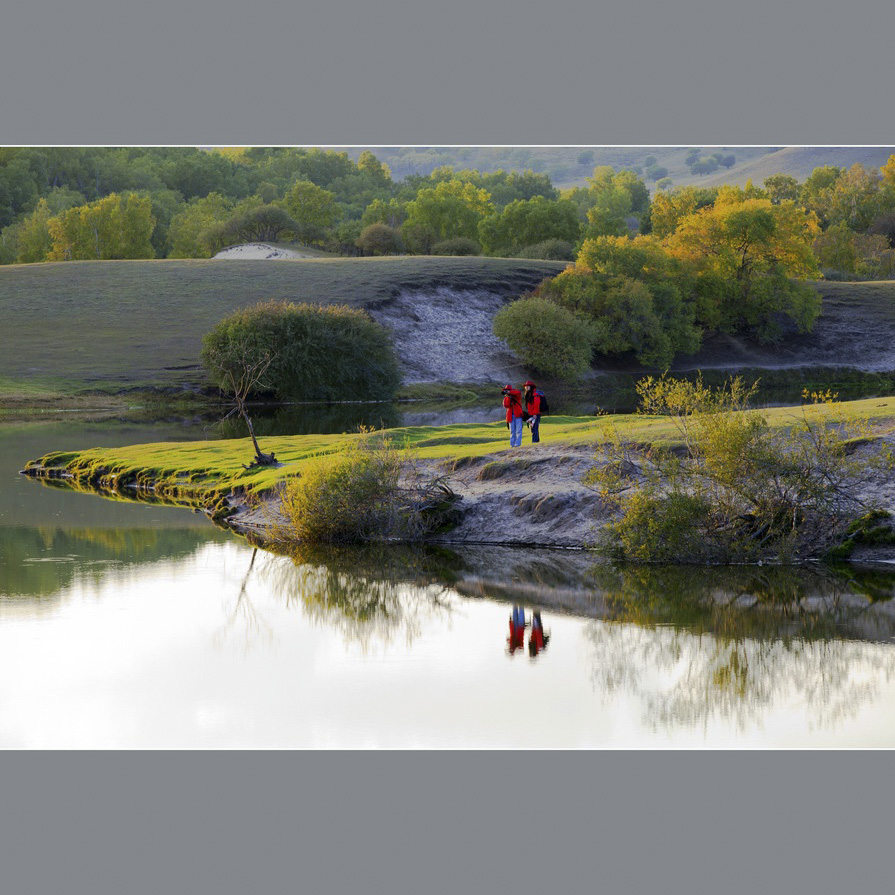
[{"x1": 494, "y1": 297, "x2": 592, "y2": 379}]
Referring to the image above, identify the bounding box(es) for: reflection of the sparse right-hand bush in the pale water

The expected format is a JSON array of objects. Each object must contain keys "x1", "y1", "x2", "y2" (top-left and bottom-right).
[{"x1": 588, "y1": 567, "x2": 895, "y2": 730}]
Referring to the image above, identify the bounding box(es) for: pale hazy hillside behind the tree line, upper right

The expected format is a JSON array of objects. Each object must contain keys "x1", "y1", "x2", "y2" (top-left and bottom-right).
[{"x1": 333, "y1": 146, "x2": 895, "y2": 189}]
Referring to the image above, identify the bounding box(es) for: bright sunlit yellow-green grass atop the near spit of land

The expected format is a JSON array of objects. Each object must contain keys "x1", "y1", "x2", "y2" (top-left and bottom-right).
[{"x1": 24, "y1": 398, "x2": 895, "y2": 505}]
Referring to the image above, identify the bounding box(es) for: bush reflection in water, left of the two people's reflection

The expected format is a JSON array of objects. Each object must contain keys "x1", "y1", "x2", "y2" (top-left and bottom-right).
[{"x1": 262, "y1": 545, "x2": 453, "y2": 647}]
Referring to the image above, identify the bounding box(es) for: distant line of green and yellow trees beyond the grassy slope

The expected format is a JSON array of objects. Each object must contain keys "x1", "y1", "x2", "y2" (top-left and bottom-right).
[{"x1": 0, "y1": 147, "x2": 895, "y2": 278}]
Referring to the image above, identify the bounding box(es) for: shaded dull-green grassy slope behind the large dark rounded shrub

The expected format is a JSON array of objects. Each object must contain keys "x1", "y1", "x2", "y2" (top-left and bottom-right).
[{"x1": 0, "y1": 257, "x2": 565, "y2": 398}]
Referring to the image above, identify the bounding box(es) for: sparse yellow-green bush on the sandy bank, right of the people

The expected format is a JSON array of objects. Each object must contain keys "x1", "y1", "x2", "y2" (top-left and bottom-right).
[{"x1": 589, "y1": 377, "x2": 892, "y2": 563}]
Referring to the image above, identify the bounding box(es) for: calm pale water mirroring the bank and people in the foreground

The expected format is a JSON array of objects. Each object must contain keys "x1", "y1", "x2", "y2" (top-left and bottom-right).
[{"x1": 0, "y1": 417, "x2": 895, "y2": 749}]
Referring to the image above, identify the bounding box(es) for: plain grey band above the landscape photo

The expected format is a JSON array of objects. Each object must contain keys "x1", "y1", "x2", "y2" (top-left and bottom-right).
[{"x1": 0, "y1": 0, "x2": 895, "y2": 145}]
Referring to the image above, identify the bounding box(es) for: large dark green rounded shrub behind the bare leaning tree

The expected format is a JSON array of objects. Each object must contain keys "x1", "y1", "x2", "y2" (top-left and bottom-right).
[{"x1": 201, "y1": 301, "x2": 401, "y2": 401}]
